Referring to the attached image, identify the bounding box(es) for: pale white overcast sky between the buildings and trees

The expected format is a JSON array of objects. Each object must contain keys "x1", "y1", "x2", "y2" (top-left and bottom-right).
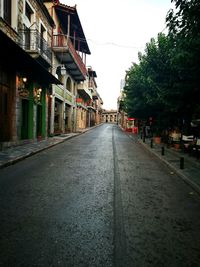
[{"x1": 60, "y1": 0, "x2": 172, "y2": 110}]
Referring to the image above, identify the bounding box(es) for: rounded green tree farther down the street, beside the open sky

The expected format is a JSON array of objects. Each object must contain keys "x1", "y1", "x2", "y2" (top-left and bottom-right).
[{"x1": 125, "y1": 33, "x2": 177, "y2": 129}]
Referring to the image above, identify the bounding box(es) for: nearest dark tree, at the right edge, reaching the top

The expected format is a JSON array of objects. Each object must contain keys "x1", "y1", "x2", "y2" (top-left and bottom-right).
[{"x1": 166, "y1": 0, "x2": 200, "y2": 124}]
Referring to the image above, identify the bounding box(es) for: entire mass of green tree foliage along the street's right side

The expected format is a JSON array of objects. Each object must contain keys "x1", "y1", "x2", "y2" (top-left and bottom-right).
[{"x1": 124, "y1": 0, "x2": 200, "y2": 132}]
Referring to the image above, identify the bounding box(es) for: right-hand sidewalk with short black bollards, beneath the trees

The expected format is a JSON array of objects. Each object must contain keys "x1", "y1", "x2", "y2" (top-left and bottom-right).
[{"x1": 135, "y1": 135, "x2": 200, "y2": 194}]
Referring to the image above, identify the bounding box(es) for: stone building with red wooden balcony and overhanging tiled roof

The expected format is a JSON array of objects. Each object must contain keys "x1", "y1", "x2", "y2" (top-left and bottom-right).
[{"x1": 44, "y1": 0, "x2": 91, "y2": 134}]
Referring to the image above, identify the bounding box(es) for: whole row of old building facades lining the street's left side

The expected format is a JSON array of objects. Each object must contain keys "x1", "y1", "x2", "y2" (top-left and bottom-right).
[{"x1": 0, "y1": 0, "x2": 103, "y2": 151}]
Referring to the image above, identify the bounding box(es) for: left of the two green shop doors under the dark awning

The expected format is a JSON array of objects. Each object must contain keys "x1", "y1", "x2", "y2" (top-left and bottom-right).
[{"x1": 21, "y1": 99, "x2": 29, "y2": 139}]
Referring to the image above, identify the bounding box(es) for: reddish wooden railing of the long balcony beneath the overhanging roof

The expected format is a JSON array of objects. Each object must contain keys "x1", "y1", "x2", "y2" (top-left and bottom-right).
[{"x1": 52, "y1": 34, "x2": 87, "y2": 76}]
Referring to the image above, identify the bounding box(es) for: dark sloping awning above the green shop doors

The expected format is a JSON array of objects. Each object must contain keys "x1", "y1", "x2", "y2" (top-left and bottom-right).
[{"x1": 0, "y1": 30, "x2": 62, "y2": 85}]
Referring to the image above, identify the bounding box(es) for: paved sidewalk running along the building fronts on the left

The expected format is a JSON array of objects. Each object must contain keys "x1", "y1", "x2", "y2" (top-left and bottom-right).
[{"x1": 0, "y1": 126, "x2": 91, "y2": 169}]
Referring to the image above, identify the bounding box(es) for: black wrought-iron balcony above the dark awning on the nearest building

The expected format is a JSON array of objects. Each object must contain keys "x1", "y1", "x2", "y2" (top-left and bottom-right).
[{"x1": 19, "y1": 29, "x2": 52, "y2": 68}]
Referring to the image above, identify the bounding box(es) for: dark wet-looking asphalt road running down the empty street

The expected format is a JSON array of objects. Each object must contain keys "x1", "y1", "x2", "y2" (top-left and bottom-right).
[{"x1": 0, "y1": 124, "x2": 200, "y2": 267}]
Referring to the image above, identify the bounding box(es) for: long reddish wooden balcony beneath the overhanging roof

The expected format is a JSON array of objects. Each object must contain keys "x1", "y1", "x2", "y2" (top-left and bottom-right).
[{"x1": 52, "y1": 34, "x2": 87, "y2": 81}]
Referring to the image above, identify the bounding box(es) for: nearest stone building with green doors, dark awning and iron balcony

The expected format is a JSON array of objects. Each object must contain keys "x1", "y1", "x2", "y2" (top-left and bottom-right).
[{"x1": 0, "y1": 0, "x2": 60, "y2": 147}]
